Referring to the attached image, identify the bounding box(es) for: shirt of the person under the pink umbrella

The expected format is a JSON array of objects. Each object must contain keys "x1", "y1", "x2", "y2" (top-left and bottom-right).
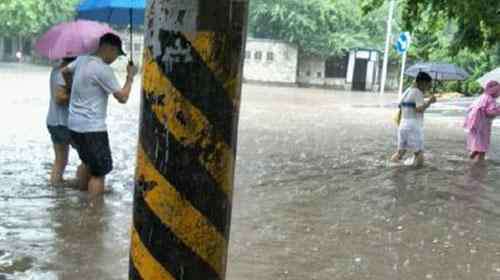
[{"x1": 47, "y1": 67, "x2": 68, "y2": 126}]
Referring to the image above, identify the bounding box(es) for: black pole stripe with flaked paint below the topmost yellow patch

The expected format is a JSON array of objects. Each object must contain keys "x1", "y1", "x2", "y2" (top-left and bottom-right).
[{"x1": 150, "y1": 30, "x2": 237, "y2": 149}]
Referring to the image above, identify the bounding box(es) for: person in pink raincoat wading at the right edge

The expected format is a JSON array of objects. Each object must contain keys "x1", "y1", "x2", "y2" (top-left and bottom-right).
[{"x1": 464, "y1": 81, "x2": 500, "y2": 162}]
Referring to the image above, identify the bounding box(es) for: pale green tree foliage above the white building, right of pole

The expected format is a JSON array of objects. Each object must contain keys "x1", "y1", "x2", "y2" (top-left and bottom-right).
[{"x1": 249, "y1": 0, "x2": 385, "y2": 56}]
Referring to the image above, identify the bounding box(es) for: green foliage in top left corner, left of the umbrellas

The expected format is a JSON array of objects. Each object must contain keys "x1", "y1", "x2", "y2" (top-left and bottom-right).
[{"x1": 0, "y1": 0, "x2": 78, "y2": 36}]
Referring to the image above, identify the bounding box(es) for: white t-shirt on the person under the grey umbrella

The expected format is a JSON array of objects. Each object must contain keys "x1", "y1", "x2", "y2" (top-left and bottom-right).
[{"x1": 400, "y1": 87, "x2": 424, "y2": 127}]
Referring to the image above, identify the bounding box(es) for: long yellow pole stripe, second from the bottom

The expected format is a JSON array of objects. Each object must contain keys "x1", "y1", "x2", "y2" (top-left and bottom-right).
[{"x1": 137, "y1": 145, "x2": 227, "y2": 279}]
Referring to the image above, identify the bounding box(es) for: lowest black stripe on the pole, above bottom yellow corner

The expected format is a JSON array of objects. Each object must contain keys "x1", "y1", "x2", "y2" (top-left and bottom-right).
[{"x1": 133, "y1": 180, "x2": 220, "y2": 280}]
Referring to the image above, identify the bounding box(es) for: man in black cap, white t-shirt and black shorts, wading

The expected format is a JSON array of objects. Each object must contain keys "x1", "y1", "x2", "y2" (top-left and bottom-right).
[{"x1": 62, "y1": 33, "x2": 137, "y2": 195}]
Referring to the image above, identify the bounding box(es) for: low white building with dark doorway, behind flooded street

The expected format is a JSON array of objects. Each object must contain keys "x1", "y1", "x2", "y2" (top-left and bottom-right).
[{"x1": 243, "y1": 38, "x2": 380, "y2": 91}]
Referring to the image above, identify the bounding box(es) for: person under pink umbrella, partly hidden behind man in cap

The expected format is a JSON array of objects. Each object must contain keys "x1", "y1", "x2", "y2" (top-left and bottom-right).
[{"x1": 47, "y1": 57, "x2": 75, "y2": 185}]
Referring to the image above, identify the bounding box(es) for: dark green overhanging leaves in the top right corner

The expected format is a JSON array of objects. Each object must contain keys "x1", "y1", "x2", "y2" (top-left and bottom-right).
[{"x1": 363, "y1": 0, "x2": 500, "y2": 53}]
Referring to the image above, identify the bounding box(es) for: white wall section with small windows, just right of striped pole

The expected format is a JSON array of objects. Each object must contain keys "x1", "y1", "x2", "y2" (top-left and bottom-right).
[{"x1": 243, "y1": 38, "x2": 298, "y2": 84}]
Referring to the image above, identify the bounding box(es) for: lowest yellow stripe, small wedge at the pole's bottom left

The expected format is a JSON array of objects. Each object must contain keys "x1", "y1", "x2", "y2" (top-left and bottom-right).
[{"x1": 130, "y1": 229, "x2": 176, "y2": 280}]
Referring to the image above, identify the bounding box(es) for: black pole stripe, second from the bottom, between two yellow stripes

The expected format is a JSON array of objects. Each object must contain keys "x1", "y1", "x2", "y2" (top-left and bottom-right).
[{"x1": 140, "y1": 92, "x2": 231, "y2": 236}]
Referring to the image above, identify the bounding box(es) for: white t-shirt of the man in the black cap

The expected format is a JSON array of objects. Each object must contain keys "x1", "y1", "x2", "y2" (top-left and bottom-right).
[{"x1": 68, "y1": 56, "x2": 121, "y2": 133}]
